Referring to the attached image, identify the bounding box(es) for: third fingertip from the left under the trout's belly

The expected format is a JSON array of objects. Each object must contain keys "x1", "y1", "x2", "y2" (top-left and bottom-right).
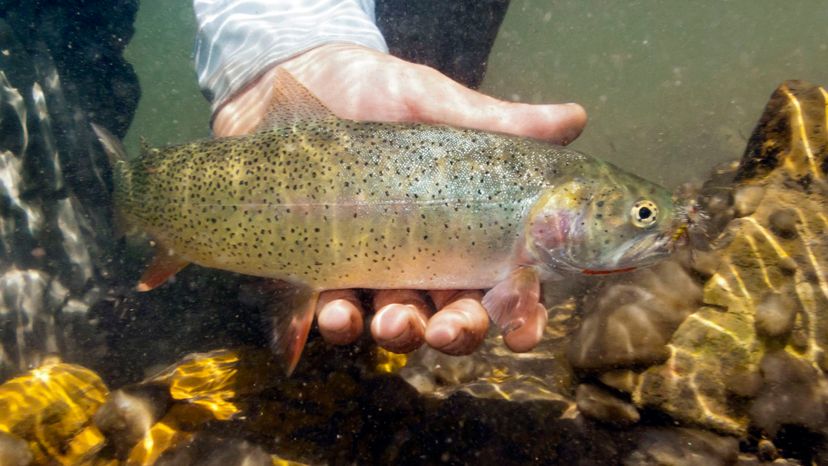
[{"x1": 425, "y1": 290, "x2": 489, "y2": 355}]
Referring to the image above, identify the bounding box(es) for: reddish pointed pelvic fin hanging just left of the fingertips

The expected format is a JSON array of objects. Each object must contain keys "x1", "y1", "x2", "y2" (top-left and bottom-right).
[{"x1": 263, "y1": 282, "x2": 319, "y2": 375}]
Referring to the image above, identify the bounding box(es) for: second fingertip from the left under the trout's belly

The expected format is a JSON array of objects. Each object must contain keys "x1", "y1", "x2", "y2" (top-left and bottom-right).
[{"x1": 371, "y1": 290, "x2": 430, "y2": 353}]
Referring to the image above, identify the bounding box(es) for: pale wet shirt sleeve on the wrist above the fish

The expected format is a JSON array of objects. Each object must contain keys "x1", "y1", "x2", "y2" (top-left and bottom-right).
[{"x1": 193, "y1": 0, "x2": 388, "y2": 111}]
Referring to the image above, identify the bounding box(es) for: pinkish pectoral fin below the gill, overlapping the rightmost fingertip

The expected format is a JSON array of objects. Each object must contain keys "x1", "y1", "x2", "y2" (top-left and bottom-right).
[{"x1": 483, "y1": 267, "x2": 540, "y2": 335}]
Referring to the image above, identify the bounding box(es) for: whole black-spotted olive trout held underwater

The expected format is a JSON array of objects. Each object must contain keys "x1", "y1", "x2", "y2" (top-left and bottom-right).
[{"x1": 96, "y1": 72, "x2": 685, "y2": 370}]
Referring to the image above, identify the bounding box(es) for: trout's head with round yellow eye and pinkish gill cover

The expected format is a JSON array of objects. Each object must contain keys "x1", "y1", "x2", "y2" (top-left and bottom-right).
[{"x1": 525, "y1": 164, "x2": 687, "y2": 275}]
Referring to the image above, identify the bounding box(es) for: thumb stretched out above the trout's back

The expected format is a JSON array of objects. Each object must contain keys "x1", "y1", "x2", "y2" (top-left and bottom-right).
[{"x1": 407, "y1": 66, "x2": 587, "y2": 144}]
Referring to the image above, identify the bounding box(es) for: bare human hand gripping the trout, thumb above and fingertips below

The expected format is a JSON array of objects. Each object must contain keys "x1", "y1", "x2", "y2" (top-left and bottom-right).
[{"x1": 213, "y1": 44, "x2": 586, "y2": 355}]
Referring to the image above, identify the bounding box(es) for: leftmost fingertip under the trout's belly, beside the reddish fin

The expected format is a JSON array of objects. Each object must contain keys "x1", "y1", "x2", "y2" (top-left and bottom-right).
[{"x1": 316, "y1": 290, "x2": 363, "y2": 345}]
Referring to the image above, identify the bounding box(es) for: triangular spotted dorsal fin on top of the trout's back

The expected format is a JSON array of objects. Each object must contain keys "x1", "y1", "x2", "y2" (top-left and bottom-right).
[{"x1": 256, "y1": 67, "x2": 336, "y2": 132}]
